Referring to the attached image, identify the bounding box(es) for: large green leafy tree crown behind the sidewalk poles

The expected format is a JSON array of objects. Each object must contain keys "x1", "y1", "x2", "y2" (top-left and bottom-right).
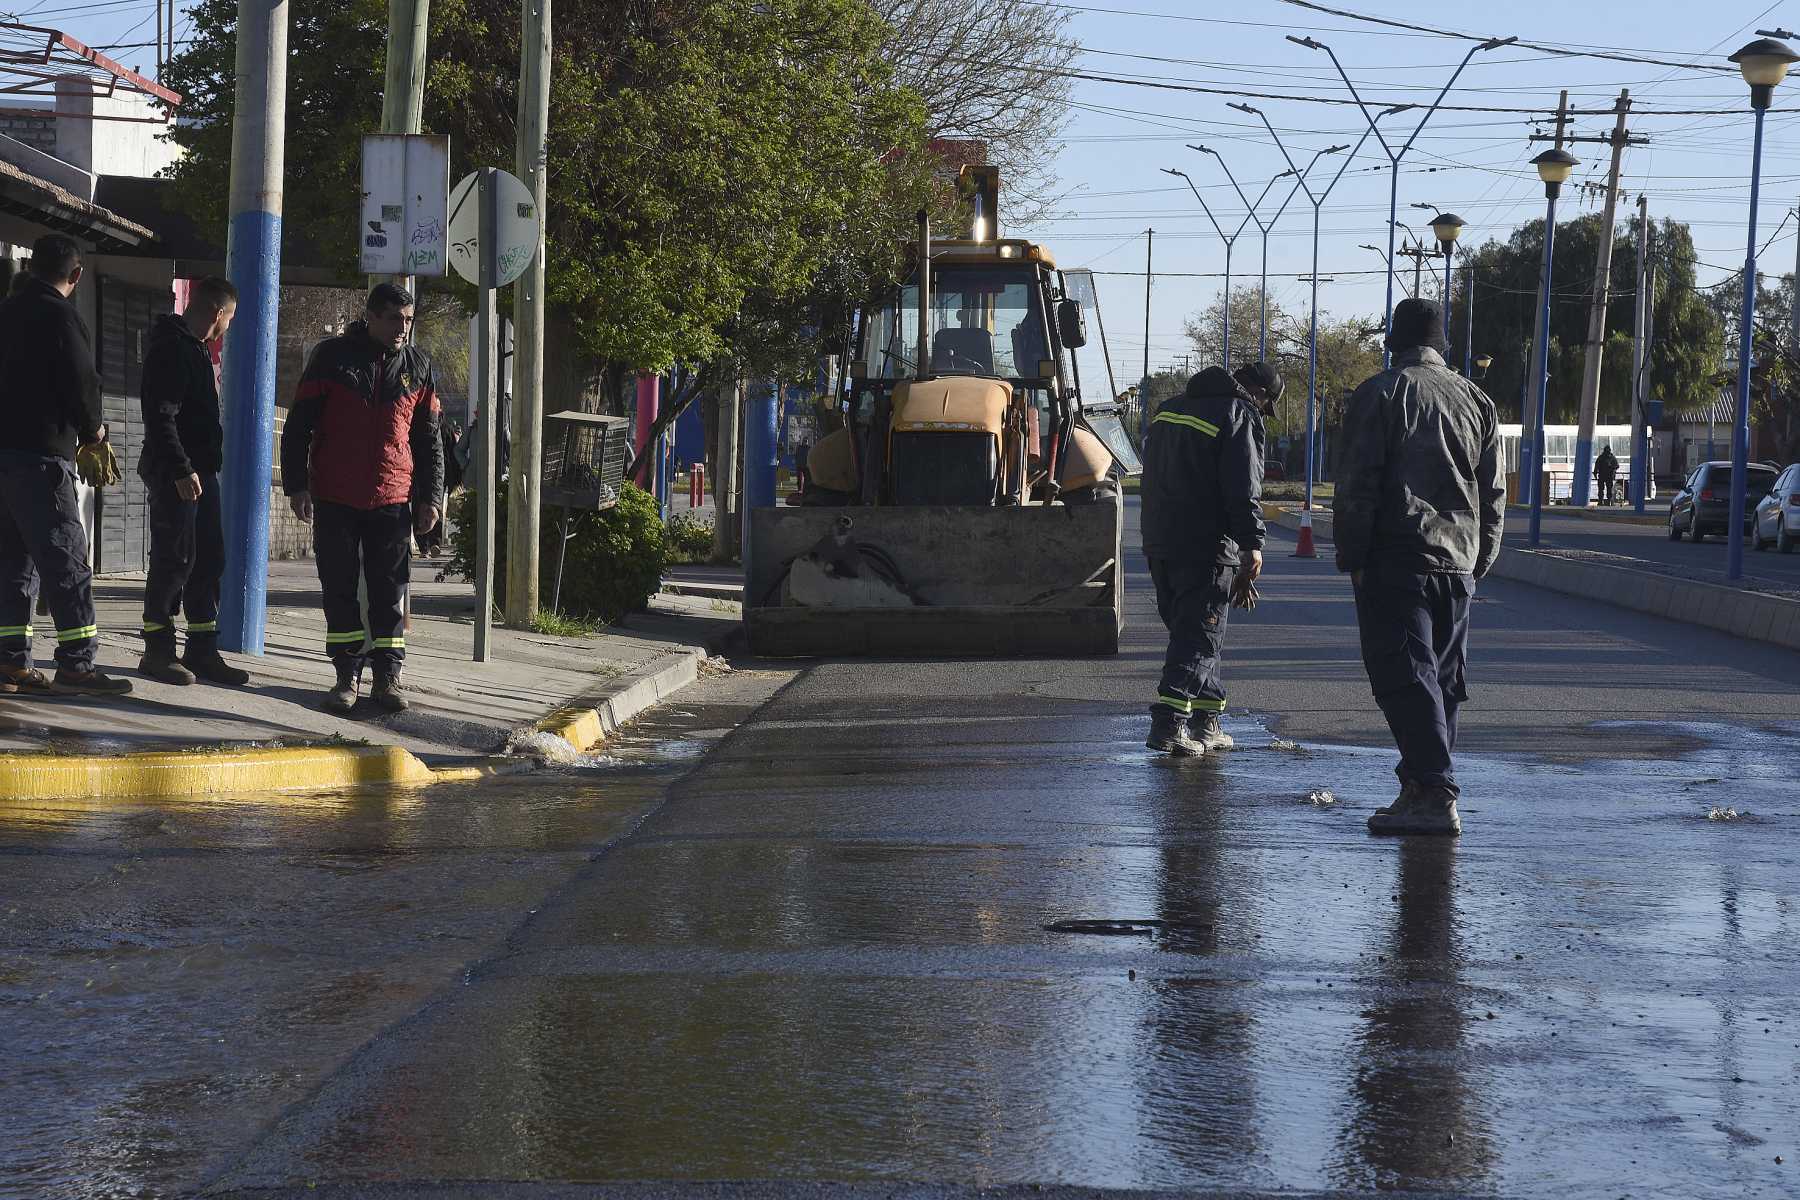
[{"x1": 158, "y1": 0, "x2": 923, "y2": 386}]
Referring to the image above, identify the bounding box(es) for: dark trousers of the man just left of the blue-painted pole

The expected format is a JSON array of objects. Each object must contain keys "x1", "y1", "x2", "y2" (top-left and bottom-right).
[{"x1": 144, "y1": 475, "x2": 225, "y2": 653}]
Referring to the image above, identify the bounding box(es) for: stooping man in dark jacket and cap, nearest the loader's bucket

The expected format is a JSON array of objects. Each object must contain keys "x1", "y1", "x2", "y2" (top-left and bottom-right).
[{"x1": 1141, "y1": 363, "x2": 1282, "y2": 757}]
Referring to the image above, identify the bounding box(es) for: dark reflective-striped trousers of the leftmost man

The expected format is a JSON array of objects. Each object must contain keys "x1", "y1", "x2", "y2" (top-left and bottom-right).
[{"x1": 0, "y1": 450, "x2": 99, "y2": 671}]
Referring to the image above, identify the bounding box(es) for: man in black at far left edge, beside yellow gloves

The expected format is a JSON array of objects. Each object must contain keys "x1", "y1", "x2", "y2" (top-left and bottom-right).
[{"x1": 0, "y1": 234, "x2": 131, "y2": 696}]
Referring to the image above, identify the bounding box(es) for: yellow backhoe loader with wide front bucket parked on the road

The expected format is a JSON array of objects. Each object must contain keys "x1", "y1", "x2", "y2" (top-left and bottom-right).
[{"x1": 743, "y1": 167, "x2": 1139, "y2": 657}]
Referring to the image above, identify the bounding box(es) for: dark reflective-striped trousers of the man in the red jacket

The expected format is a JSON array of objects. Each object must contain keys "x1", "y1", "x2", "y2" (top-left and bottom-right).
[{"x1": 313, "y1": 500, "x2": 412, "y2": 675}]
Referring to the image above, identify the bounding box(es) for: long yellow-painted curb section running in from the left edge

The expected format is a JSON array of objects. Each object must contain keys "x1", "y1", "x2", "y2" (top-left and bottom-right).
[{"x1": 0, "y1": 747, "x2": 446, "y2": 802}]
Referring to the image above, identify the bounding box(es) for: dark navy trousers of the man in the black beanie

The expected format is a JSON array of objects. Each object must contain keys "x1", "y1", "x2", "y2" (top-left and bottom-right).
[{"x1": 1355, "y1": 567, "x2": 1474, "y2": 792}]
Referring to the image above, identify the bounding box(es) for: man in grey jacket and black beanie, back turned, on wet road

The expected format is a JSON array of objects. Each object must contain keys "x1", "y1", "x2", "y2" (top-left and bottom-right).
[{"x1": 1332, "y1": 300, "x2": 1507, "y2": 835}]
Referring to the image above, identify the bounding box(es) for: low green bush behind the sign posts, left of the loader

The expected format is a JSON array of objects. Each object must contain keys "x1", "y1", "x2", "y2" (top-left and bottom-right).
[{"x1": 448, "y1": 484, "x2": 668, "y2": 624}]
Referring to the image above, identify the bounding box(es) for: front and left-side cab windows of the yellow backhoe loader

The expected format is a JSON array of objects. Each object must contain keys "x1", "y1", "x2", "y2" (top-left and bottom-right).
[{"x1": 860, "y1": 266, "x2": 1049, "y2": 380}]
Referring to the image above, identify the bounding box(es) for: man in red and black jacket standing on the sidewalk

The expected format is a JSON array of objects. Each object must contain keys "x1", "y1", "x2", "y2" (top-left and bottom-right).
[{"x1": 281, "y1": 284, "x2": 445, "y2": 712}]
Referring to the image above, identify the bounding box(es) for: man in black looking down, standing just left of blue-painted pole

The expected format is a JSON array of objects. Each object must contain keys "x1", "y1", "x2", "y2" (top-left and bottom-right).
[{"x1": 137, "y1": 275, "x2": 250, "y2": 687}]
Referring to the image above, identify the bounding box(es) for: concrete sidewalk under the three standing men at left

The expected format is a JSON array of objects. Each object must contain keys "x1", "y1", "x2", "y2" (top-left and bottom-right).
[{"x1": 0, "y1": 561, "x2": 736, "y2": 795}]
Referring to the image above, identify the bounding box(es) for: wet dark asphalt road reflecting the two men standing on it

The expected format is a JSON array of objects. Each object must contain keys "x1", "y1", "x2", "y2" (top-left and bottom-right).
[{"x1": 0, "y1": 503, "x2": 1800, "y2": 1196}]
